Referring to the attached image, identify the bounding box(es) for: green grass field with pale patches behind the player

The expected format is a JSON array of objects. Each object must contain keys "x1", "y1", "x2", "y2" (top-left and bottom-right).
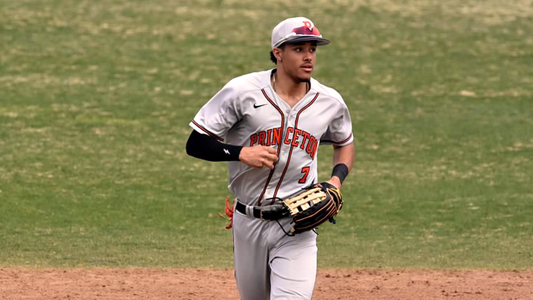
[{"x1": 0, "y1": 0, "x2": 533, "y2": 270}]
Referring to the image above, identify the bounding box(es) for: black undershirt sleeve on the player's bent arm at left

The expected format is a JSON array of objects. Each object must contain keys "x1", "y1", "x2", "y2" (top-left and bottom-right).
[{"x1": 186, "y1": 130, "x2": 242, "y2": 161}]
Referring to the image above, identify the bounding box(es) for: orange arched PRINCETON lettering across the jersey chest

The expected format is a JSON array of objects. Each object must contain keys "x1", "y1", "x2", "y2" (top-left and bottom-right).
[{"x1": 250, "y1": 127, "x2": 318, "y2": 159}]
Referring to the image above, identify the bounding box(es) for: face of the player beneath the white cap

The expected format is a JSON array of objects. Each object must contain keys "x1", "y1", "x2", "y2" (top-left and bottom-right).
[{"x1": 282, "y1": 42, "x2": 317, "y2": 82}]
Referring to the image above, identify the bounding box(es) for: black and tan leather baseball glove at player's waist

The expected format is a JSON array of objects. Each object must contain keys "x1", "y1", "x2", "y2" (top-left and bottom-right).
[{"x1": 283, "y1": 182, "x2": 344, "y2": 234}]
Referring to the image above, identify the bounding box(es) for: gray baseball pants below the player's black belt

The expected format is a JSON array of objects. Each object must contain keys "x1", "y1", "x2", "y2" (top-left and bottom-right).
[{"x1": 233, "y1": 205, "x2": 318, "y2": 300}]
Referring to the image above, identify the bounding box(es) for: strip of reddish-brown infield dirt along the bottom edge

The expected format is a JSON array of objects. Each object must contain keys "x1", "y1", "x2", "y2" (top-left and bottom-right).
[{"x1": 0, "y1": 268, "x2": 533, "y2": 300}]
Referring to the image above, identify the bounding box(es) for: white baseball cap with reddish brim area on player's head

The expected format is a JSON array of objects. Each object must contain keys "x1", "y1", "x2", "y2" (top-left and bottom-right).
[{"x1": 272, "y1": 17, "x2": 329, "y2": 49}]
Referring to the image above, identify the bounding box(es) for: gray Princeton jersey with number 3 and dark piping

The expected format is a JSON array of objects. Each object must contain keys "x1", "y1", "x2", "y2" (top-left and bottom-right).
[{"x1": 190, "y1": 70, "x2": 353, "y2": 205}]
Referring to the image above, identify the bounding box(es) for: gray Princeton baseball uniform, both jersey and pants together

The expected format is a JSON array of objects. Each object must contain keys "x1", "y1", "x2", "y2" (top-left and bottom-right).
[{"x1": 190, "y1": 70, "x2": 353, "y2": 300}]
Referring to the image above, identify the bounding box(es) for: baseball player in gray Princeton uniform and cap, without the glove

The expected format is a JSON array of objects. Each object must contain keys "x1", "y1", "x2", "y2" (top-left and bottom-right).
[{"x1": 187, "y1": 17, "x2": 355, "y2": 300}]
